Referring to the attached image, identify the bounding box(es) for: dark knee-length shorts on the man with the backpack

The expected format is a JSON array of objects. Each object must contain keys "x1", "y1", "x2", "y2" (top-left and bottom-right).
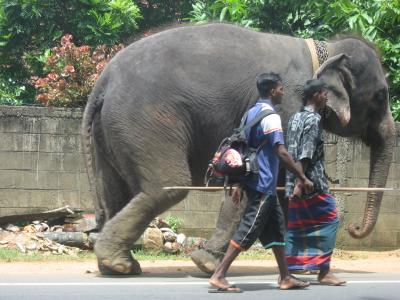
[{"x1": 231, "y1": 188, "x2": 285, "y2": 250}]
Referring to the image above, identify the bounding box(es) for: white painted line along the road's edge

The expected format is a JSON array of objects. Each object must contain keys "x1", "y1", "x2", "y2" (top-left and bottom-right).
[{"x1": 0, "y1": 280, "x2": 400, "y2": 286}]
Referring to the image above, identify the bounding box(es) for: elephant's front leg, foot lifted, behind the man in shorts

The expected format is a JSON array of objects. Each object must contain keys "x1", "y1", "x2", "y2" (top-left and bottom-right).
[{"x1": 191, "y1": 193, "x2": 247, "y2": 274}]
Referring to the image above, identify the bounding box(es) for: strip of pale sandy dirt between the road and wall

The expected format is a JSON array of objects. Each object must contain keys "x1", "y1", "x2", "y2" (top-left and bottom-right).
[{"x1": 0, "y1": 250, "x2": 400, "y2": 274}]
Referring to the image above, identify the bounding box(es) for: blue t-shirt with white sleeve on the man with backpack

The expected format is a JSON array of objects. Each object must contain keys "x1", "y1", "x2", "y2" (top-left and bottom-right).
[{"x1": 243, "y1": 99, "x2": 285, "y2": 195}]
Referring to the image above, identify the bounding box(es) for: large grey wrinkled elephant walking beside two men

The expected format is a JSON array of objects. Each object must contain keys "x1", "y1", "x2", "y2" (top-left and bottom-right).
[{"x1": 83, "y1": 24, "x2": 394, "y2": 274}]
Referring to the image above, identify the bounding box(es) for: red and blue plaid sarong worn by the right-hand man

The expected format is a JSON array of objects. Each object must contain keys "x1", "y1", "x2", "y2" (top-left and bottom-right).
[{"x1": 285, "y1": 194, "x2": 339, "y2": 270}]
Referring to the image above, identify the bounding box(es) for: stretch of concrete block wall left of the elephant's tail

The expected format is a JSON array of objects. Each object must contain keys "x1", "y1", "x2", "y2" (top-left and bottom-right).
[{"x1": 0, "y1": 106, "x2": 92, "y2": 215}]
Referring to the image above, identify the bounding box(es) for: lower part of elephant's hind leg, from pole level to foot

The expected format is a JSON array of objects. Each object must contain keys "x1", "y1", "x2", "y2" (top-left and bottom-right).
[{"x1": 94, "y1": 190, "x2": 187, "y2": 275}]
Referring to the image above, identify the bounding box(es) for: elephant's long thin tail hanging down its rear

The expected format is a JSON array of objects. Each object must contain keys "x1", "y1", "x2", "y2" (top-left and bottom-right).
[{"x1": 81, "y1": 84, "x2": 104, "y2": 217}]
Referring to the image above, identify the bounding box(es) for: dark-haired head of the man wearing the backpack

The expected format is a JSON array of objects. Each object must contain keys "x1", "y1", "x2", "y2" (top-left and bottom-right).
[{"x1": 257, "y1": 72, "x2": 283, "y2": 104}]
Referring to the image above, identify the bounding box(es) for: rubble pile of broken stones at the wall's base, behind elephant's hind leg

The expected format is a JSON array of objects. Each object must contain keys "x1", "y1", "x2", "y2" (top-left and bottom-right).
[{"x1": 0, "y1": 207, "x2": 206, "y2": 255}]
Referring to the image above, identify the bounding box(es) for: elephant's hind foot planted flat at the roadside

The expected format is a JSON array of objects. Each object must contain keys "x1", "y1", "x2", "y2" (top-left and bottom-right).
[{"x1": 94, "y1": 241, "x2": 142, "y2": 275}]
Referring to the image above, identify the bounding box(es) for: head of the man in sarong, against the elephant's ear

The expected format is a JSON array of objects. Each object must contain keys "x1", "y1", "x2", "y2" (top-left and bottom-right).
[{"x1": 303, "y1": 79, "x2": 328, "y2": 109}]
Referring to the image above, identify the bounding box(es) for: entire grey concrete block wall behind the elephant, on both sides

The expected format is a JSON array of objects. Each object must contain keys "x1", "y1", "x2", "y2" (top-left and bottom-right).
[{"x1": 0, "y1": 106, "x2": 400, "y2": 250}]
